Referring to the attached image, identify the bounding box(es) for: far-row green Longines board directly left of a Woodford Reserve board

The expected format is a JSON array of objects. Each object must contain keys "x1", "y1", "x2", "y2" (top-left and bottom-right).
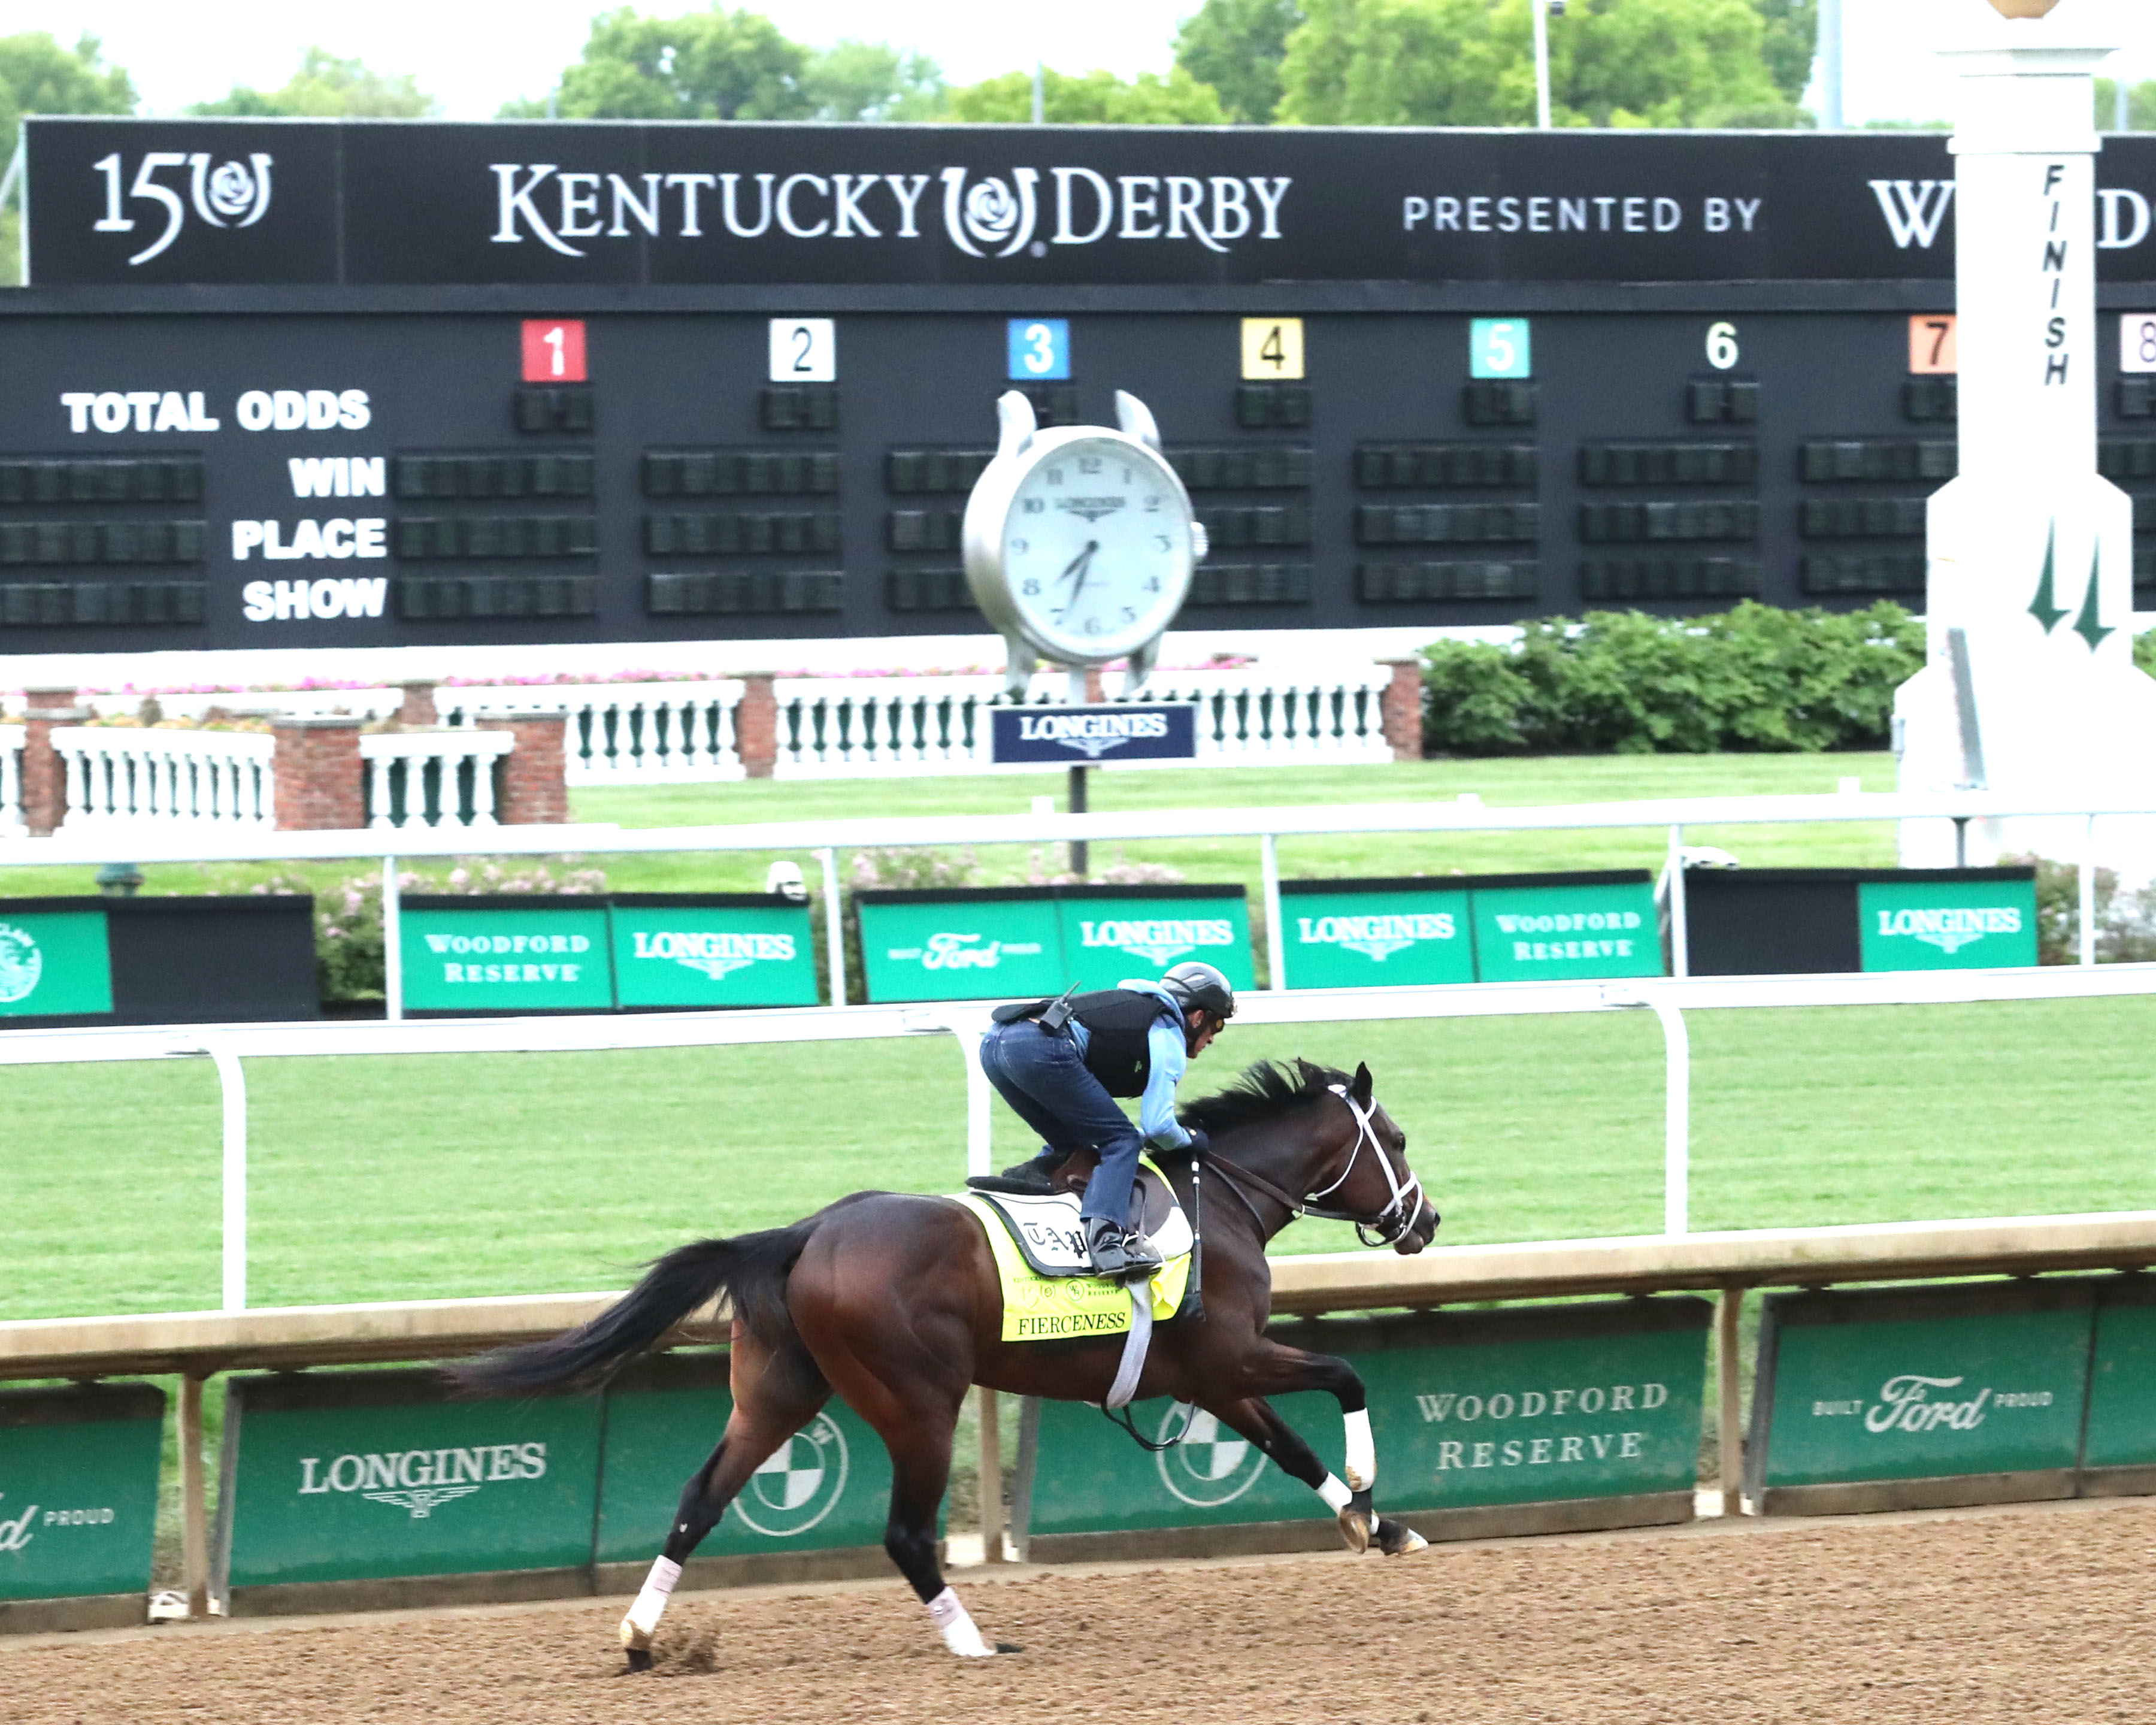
[{"x1": 1280, "y1": 880, "x2": 1474, "y2": 988}]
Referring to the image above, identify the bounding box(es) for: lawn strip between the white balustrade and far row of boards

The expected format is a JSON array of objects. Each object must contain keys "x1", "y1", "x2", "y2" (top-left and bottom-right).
[{"x1": 0, "y1": 755, "x2": 1893, "y2": 897}]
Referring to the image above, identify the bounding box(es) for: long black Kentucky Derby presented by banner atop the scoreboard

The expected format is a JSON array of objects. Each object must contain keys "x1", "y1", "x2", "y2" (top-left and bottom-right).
[{"x1": 26, "y1": 119, "x2": 2156, "y2": 285}]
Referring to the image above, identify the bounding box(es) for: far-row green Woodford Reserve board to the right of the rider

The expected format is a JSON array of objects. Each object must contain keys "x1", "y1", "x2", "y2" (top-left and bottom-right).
[{"x1": 1462, "y1": 869, "x2": 1663, "y2": 983}]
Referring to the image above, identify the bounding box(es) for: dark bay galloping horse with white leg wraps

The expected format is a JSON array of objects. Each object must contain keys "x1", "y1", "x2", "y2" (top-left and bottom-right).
[{"x1": 450, "y1": 1061, "x2": 1438, "y2": 1671}]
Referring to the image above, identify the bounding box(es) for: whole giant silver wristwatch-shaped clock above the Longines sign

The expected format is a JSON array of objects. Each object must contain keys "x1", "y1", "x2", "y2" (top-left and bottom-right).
[{"x1": 964, "y1": 391, "x2": 1205, "y2": 694}]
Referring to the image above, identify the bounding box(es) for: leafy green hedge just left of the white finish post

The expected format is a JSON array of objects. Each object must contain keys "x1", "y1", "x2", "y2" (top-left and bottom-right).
[{"x1": 1423, "y1": 601, "x2": 1923, "y2": 755}]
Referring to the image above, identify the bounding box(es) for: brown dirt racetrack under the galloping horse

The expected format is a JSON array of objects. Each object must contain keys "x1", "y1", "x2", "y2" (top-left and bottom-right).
[{"x1": 0, "y1": 1501, "x2": 2156, "y2": 1725}]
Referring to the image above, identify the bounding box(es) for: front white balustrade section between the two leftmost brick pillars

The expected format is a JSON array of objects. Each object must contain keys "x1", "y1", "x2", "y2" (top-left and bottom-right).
[{"x1": 52, "y1": 725, "x2": 276, "y2": 833}]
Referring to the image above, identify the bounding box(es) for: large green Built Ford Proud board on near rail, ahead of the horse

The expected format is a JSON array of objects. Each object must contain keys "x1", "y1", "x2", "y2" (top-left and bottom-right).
[{"x1": 1746, "y1": 1281, "x2": 2094, "y2": 1514}]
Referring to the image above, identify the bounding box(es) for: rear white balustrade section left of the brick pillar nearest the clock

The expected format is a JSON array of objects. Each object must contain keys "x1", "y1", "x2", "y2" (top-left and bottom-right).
[{"x1": 434, "y1": 679, "x2": 746, "y2": 785}]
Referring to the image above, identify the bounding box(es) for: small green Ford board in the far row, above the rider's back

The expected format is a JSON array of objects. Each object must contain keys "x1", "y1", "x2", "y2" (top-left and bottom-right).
[{"x1": 854, "y1": 888, "x2": 1070, "y2": 1000}]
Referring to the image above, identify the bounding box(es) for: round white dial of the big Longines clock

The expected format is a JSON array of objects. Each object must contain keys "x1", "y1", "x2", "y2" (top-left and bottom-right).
[{"x1": 1003, "y1": 438, "x2": 1192, "y2": 658}]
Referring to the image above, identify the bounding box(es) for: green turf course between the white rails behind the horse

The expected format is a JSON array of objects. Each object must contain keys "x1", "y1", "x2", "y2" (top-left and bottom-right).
[{"x1": 0, "y1": 998, "x2": 2156, "y2": 1318}]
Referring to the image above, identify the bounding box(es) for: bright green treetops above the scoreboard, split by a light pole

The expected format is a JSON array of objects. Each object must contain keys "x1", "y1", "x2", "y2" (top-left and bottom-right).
[{"x1": 1279, "y1": 0, "x2": 1809, "y2": 127}]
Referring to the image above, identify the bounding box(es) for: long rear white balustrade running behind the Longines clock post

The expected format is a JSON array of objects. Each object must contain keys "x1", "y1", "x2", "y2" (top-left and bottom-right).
[{"x1": 435, "y1": 664, "x2": 1393, "y2": 785}]
